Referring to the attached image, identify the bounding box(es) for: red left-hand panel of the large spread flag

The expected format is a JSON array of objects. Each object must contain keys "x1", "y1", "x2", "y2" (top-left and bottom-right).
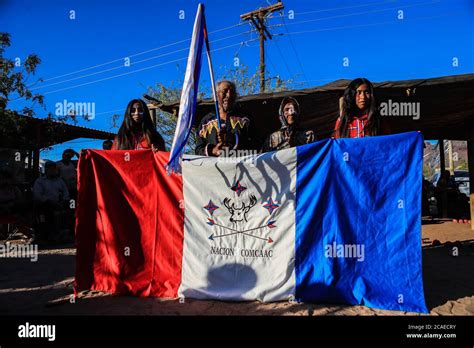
[{"x1": 75, "y1": 150, "x2": 184, "y2": 297}]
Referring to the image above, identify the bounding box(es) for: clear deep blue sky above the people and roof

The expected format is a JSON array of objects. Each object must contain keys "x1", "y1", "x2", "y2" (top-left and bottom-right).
[{"x1": 0, "y1": 0, "x2": 474, "y2": 159}]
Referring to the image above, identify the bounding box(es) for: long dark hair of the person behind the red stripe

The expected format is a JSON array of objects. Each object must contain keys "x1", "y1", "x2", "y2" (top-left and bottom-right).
[{"x1": 117, "y1": 99, "x2": 165, "y2": 151}]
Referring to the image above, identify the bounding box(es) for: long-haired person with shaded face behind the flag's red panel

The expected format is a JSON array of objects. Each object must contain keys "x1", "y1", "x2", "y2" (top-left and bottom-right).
[{"x1": 112, "y1": 99, "x2": 165, "y2": 151}]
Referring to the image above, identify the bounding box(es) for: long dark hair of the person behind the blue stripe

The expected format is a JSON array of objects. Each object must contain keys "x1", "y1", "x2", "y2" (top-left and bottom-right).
[{"x1": 336, "y1": 77, "x2": 380, "y2": 138}]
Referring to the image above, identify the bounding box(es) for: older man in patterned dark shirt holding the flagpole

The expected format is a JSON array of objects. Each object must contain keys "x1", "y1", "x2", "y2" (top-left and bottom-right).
[{"x1": 195, "y1": 80, "x2": 259, "y2": 156}]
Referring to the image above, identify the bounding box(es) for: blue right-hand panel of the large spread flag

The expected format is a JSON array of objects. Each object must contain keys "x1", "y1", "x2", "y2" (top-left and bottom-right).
[{"x1": 295, "y1": 132, "x2": 428, "y2": 313}]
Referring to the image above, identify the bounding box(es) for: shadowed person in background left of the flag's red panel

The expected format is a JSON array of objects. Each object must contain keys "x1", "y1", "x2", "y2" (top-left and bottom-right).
[{"x1": 33, "y1": 162, "x2": 69, "y2": 241}]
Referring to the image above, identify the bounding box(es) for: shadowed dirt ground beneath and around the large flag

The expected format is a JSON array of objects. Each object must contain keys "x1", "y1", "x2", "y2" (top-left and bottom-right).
[{"x1": 0, "y1": 220, "x2": 474, "y2": 316}]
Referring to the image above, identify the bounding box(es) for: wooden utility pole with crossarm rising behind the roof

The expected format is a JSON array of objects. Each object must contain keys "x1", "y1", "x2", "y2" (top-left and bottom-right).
[{"x1": 240, "y1": 1, "x2": 283, "y2": 93}]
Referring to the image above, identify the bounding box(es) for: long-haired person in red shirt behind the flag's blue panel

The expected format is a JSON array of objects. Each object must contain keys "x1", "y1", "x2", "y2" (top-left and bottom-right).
[{"x1": 334, "y1": 78, "x2": 390, "y2": 139}]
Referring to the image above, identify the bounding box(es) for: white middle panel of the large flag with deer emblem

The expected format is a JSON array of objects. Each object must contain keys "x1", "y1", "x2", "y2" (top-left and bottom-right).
[{"x1": 178, "y1": 148, "x2": 296, "y2": 301}]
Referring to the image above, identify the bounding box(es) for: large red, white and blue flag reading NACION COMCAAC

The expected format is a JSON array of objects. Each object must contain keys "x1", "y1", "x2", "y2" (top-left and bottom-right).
[{"x1": 75, "y1": 132, "x2": 427, "y2": 313}]
